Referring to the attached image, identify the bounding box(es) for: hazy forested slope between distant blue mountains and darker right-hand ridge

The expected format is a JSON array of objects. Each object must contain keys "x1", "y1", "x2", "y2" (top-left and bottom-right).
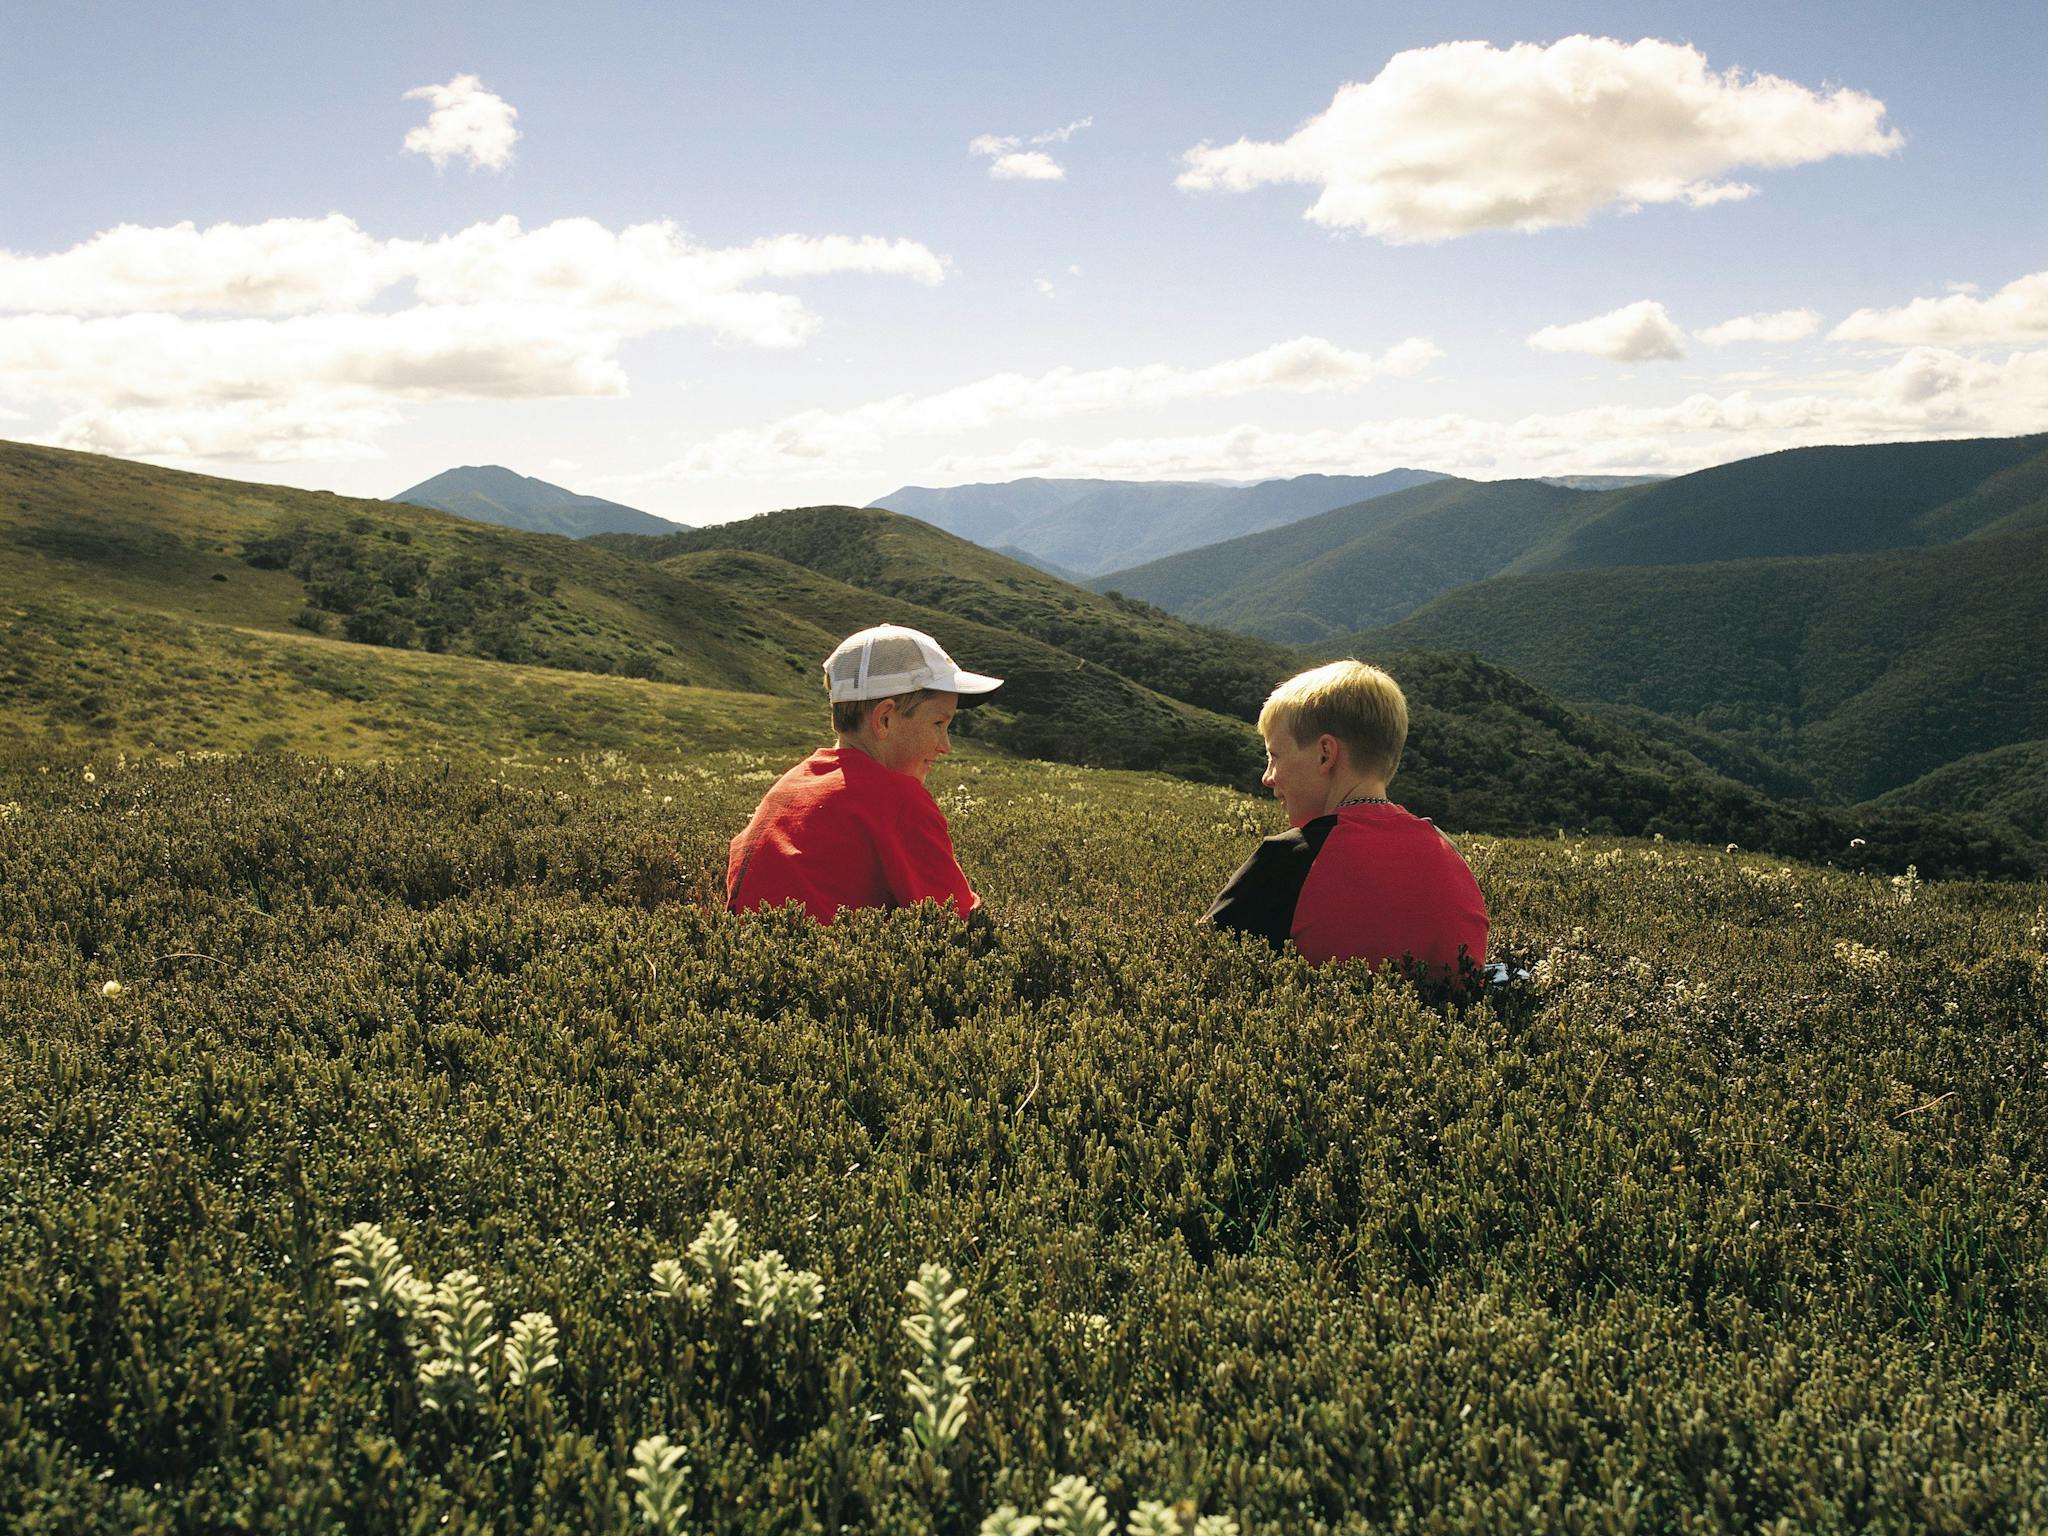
[{"x1": 1092, "y1": 479, "x2": 1587, "y2": 645}]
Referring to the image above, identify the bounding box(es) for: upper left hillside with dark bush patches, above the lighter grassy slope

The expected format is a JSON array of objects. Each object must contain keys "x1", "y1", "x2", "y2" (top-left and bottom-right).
[{"x1": 0, "y1": 442, "x2": 831, "y2": 696}]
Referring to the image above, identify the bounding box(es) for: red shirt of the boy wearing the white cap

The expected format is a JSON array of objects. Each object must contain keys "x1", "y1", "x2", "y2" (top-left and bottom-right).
[{"x1": 725, "y1": 748, "x2": 981, "y2": 924}]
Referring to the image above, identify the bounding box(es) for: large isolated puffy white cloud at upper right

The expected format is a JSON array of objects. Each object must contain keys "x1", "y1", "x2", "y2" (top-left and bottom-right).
[{"x1": 1178, "y1": 37, "x2": 1903, "y2": 244}]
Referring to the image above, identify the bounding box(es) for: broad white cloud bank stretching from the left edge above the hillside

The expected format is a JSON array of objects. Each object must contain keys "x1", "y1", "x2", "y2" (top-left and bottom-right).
[{"x1": 0, "y1": 215, "x2": 946, "y2": 463}]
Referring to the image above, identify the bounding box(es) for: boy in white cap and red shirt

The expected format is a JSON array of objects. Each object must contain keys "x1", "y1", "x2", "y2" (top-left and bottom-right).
[{"x1": 725, "y1": 625, "x2": 1001, "y2": 924}]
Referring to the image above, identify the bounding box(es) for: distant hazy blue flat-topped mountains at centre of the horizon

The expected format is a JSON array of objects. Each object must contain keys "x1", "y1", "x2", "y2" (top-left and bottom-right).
[{"x1": 868, "y1": 469, "x2": 1440, "y2": 575}]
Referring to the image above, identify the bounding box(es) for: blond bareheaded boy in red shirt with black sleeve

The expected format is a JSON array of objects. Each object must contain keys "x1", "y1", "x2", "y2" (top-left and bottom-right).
[{"x1": 1202, "y1": 659, "x2": 1487, "y2": 975}]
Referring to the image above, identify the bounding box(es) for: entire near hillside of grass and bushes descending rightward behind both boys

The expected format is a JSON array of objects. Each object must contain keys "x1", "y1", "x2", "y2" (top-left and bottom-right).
[{"x1": 0, "y1": 444, "x2": 2015, "y2": 874}]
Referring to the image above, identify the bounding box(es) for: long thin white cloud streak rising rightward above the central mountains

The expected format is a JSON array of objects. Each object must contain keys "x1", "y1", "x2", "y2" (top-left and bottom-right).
[{"x1": 621, "y1": 336, "x2": 1442, "y2": 483}]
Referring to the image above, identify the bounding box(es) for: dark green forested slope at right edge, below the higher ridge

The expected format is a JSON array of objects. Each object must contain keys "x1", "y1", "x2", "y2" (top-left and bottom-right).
[{"x1": 1360, "y1": 530, "x2": 2048, "y2": 801}]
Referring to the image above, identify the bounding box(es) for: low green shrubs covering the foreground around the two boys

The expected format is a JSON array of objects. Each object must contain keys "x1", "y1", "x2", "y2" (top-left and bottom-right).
[{"x1": 0, "y1": 756, "x2": 2048, "y2": 1532}]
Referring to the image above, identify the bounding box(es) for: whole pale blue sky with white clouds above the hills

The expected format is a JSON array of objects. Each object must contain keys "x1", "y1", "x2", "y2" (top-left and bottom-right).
[{"x1": 0, "y1": 0, "x2": 2048, "y2": 522}]
